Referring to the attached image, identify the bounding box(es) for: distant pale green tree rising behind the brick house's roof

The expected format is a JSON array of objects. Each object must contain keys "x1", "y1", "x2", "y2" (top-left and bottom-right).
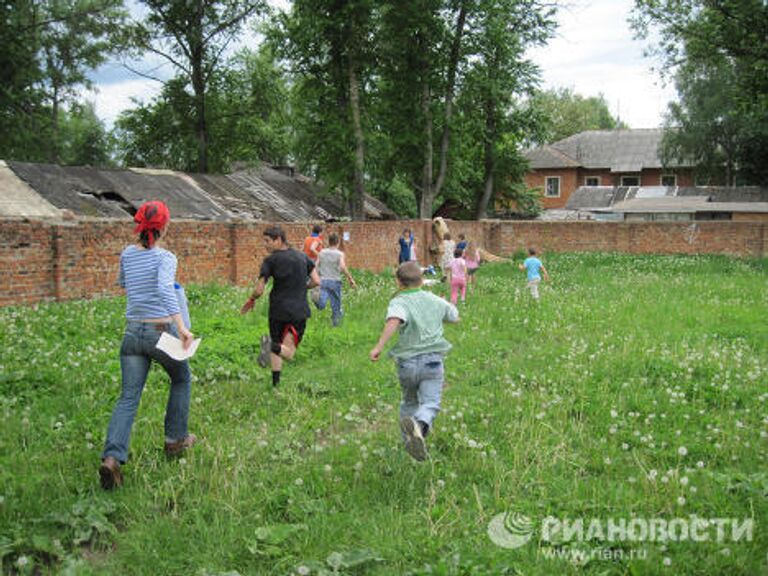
[{"x1": 529, "y1": 88, "x2": 628, "y2": 145}]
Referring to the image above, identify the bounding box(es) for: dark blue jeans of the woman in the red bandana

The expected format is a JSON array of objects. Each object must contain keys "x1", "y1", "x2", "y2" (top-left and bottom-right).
[{"x1": 102, "y1": 321, "x2": 192, "y2": 463}]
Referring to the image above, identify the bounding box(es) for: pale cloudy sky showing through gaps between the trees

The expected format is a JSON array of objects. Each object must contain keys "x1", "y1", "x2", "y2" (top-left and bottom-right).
[{"x1": 85, "y1": 0, "x2": 675, "y2": 128}]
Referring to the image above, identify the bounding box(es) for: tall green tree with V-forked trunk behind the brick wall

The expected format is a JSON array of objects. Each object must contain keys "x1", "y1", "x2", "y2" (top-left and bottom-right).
[{"x1": 378, "y1": 0, "x2": 468, "y2": 218}]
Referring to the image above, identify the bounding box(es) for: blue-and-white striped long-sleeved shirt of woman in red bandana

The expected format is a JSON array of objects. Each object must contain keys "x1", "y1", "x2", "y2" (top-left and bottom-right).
[{"x1": 120, "y1": 244, "x2": 180, "y2": 320}]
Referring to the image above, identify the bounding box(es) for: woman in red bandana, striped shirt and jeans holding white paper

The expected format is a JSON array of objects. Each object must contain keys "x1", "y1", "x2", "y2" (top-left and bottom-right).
[{"x1": 99, "y1": 200, "x2": 197, "y2": 490}]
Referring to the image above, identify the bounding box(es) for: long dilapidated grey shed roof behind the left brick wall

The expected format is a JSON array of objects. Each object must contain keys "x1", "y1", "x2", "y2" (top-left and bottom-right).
[{"x1": 0, "y1": 162, "x2": 396, "y2": 222}]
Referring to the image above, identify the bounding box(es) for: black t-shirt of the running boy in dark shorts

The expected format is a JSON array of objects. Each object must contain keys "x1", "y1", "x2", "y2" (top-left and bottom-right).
[{"x1": 259, "y1": 248, "x2": 315, "y2": 321}]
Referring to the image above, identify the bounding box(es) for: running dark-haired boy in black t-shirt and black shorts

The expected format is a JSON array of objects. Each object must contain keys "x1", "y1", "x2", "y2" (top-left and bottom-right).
[{"x1": 240, "y1": 226, "x2": 320, "y2": 386}]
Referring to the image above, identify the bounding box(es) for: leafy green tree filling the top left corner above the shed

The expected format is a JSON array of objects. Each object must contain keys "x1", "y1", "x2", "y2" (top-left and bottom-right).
[{"x1": 0, "y1": 0, "x2": 126, "y2": 162}]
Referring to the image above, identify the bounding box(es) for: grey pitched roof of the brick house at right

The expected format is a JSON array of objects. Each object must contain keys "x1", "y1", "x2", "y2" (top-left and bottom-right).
[{"x1": 525, "y1": 128, "x2": 690, "y2": 172}]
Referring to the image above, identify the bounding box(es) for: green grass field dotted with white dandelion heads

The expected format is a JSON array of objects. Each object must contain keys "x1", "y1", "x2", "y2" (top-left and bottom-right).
[{"x1": 0, "y1": 254, "x2": 768, "y2": 576}]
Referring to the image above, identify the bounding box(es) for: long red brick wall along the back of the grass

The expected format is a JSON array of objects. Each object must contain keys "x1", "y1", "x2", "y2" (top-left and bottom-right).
[{"x1": 0, "y1": 220, "x2": 768, "y2": 306}]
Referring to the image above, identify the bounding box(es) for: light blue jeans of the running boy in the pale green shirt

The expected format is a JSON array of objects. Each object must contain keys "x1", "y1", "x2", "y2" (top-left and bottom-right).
[{"x1": 397, "y1": 353, "x2": 444, "y2": 428}]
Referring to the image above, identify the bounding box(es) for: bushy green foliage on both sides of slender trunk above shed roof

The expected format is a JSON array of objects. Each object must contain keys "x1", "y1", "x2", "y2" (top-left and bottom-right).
[{"x1": 114, "y1": 49, "x2": 290, "y2": 172}]
